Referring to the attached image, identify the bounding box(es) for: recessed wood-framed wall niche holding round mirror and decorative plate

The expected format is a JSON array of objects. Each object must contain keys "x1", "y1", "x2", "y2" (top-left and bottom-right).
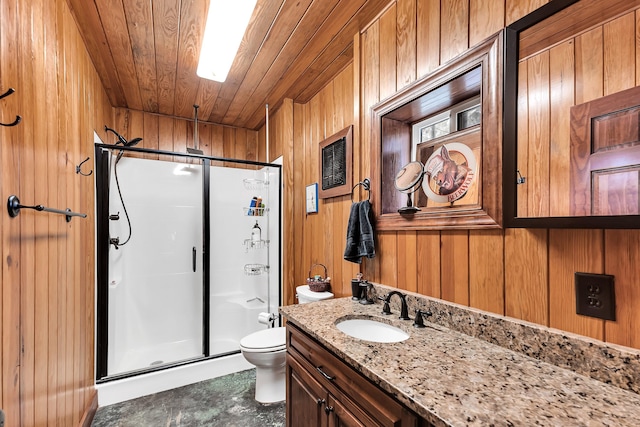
[{"x1": 371, "y1": 32, "x2": 503, "y2": 230}]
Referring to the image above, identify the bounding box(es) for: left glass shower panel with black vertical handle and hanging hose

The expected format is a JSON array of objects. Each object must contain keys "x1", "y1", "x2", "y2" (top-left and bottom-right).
[{"x1": 107, "y1": 155, "x2": 203, "y2": 376}]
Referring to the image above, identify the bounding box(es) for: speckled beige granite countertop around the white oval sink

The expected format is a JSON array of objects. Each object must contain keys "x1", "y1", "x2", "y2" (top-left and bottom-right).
[{"x1": 280, "y1": 297, "x2": 640, "y2": 426}]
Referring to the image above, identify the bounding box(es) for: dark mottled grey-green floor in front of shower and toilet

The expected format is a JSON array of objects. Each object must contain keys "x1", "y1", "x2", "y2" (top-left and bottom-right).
[{"x1": 91, "y1": 369, "x2": 285, "y2": 427}]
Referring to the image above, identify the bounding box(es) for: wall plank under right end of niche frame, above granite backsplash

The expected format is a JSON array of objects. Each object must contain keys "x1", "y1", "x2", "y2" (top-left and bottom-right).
[{"x1": 469, "y1": 230, "x2": 505, "y2": 315}]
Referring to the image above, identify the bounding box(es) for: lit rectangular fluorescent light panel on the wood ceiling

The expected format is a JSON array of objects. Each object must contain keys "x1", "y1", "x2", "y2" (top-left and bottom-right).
[{"x1": 197, "y1": 0, "x2": 257, "y2": 82}]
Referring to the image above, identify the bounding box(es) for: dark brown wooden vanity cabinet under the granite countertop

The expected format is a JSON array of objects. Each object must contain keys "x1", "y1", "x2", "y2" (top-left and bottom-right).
[{"x1": 286, "y1": 322, "x2": 428, "y2": 427}]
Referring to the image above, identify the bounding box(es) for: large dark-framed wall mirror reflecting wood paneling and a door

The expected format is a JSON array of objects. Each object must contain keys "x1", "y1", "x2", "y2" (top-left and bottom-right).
[{"x1": 503, "y1": 0, "x2": 640, "y2": 228}]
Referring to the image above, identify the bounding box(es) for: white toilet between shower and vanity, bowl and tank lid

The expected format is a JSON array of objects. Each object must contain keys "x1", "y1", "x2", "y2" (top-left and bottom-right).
[{"x1": 240, "y1": 285, "x2": 333, "y2": 403}]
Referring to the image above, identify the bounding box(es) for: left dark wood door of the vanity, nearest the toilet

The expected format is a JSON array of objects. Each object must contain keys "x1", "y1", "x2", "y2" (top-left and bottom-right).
[{"x1": 287, "y1": 354, "x2": 328, "y2": 427}]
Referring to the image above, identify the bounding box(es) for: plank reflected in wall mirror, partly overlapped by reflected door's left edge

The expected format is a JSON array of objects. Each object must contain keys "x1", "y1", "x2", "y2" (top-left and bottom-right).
[{"x1": 549, "y1": 41, "x2": 575, "y2": 216}]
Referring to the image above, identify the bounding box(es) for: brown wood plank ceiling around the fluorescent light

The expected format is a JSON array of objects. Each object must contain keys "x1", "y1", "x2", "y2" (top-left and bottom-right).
[{"x1": 67, "y1": 0, "x2": 390, "y2": 129}]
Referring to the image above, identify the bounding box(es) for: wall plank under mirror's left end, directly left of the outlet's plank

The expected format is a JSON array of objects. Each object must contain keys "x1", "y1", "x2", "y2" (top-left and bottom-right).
[{"x1": 504, "y1": 228, "x2": 549, "y2": 326}]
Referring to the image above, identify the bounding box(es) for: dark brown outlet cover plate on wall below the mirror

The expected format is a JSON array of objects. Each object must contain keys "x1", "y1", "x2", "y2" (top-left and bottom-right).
[{"x1": 575, "y1": 273, "x2": 616, "y2": 320}]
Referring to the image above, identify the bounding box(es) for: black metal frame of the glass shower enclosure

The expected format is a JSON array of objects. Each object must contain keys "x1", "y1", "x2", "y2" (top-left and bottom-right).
[{"x1": 94, "y1": 144, "x2": 282, "y2": 384}]
